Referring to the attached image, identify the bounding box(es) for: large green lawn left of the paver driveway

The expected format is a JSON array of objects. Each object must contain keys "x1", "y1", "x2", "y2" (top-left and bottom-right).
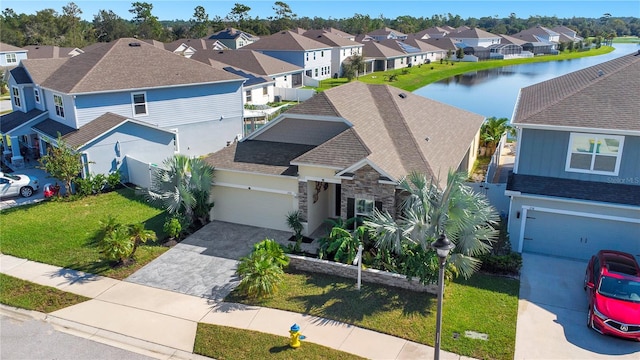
[{"x1": 0, "y1": 188, "x2": 167, "y2": 279}]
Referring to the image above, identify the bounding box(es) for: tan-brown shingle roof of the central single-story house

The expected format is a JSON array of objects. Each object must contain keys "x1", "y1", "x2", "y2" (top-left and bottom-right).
[{"x1": 209, "y1": 81, "x2": 484, "y2": 185}]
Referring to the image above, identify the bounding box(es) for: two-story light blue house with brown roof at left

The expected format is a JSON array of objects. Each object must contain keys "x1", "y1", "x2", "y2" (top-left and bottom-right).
[{"x1": 0, "y1": 38, "x2": 245, "y2": 184}]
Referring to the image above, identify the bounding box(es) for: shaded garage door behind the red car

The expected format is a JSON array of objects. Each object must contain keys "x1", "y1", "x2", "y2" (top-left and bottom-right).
[{"x1": 522, "y1": 210, "x2": 640, "y2": 260}]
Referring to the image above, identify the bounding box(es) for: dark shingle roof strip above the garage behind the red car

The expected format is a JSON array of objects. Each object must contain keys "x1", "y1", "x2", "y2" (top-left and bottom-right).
[{"x1": 507, "y1": 174, "x2": 640, "y2": 205}]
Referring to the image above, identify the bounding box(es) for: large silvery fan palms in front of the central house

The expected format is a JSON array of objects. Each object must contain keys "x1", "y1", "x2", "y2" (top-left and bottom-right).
[{"x1": 364, "y1": 172, "x2": 499, "y2": 279}]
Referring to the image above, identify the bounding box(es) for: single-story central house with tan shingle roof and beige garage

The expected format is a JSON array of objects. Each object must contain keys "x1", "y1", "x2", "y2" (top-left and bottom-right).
[{"x1": 205, "y1": 81, "x2": 484, "y2": 235}]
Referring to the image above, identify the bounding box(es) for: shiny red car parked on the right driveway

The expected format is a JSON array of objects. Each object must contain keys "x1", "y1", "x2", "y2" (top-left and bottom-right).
[{"x1": 584, "y1": 250, "x2": 640, "y2": 341}]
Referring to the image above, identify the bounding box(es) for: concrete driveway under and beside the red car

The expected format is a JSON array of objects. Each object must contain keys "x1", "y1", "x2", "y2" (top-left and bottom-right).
[{"x1": 514, "y1": 254, "x2": 640, "y2": 360}]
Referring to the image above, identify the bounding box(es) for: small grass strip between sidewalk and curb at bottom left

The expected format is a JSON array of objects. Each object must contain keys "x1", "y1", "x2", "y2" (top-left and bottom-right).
[{"x1": 0, "y1": 274, "x2": 89, "y2": 313}]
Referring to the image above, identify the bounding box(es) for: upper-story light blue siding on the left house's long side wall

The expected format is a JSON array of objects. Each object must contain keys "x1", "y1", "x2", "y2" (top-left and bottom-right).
[{"x1": 75, "y1": 82, "x2": 243, "y2": 128}]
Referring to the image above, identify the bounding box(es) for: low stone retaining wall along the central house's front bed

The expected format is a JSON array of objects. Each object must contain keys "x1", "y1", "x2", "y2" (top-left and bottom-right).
[{"x1": 287, "y1": 254, "x2": 438, "y2": 295}]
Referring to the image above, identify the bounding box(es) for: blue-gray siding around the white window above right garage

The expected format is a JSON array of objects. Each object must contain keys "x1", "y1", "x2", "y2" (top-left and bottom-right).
[{"x1": 518, "y1": 129, "x2": 640, "y2": 186}]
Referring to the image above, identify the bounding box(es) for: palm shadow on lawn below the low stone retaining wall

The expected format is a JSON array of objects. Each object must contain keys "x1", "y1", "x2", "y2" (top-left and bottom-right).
[{"x1": 290, "y1": 273, "x2": 437, "y2": 323}]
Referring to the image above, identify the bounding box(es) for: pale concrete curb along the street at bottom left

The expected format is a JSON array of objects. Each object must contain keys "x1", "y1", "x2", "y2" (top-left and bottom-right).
[{"x1": 0, "y1": 304, "x2": 211, "y2": 360}]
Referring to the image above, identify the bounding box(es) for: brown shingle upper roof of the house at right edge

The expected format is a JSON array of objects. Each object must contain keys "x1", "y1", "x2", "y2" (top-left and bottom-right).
[{"x1": 512, "y1": 52, "x2": 640, "y2": 131}]
